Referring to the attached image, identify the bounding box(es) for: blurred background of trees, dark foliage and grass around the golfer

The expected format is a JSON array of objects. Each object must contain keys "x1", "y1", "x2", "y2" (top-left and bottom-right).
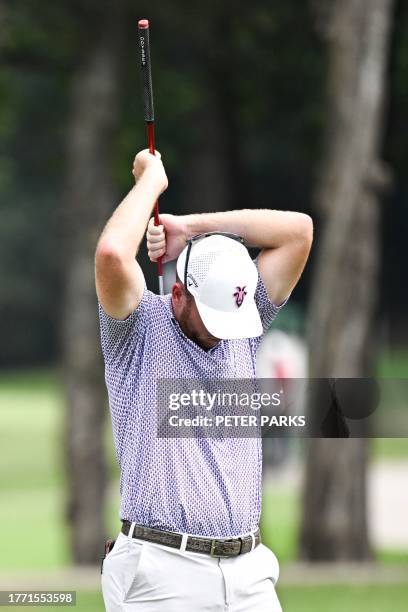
[{"x1": 0, "y1": 0, "x2": 408, "y2": 612}]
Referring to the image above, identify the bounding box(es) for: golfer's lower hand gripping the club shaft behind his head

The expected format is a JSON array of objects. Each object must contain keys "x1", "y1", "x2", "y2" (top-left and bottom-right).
[{"x1": 146, "y1": 214, "x2": 190, "y2": 263}]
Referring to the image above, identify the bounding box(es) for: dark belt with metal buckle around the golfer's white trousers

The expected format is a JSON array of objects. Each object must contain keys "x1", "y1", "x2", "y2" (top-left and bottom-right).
[{"x1": 122, "y1": 520, "x2": 261, "y2": 557}]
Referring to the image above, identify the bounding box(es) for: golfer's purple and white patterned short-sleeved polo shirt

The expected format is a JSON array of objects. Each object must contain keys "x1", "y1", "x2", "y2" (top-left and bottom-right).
[{"x1": 99, "y1": 260, "x2": 286, "y2": 538}]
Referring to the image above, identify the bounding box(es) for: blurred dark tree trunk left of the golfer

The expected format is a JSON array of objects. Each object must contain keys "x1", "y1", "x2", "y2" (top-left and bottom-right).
[{"x1": 63, "y1": 8, "x2": 121, "y2": 563}]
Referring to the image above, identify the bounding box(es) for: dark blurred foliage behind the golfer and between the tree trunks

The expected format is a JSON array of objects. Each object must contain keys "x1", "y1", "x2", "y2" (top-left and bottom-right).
[{"x1": 0, "y1": 0, "x2": 408, "y2": 367}]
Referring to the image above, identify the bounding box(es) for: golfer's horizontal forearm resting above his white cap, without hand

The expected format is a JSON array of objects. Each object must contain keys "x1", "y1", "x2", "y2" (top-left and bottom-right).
[{"x1": 184, "y1": 209, "x2": 311, "y2": 249}]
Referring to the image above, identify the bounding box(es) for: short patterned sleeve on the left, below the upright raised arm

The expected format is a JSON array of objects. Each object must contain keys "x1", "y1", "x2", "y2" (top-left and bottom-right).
[{"x1": 98, "y1": 286, "x2": 153, "y2": 366}]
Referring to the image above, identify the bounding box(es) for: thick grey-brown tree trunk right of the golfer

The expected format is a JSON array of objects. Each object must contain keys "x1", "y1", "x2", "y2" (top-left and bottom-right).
[{"x1": 300, "y1": 0, "x2": 393, "y2": 560}]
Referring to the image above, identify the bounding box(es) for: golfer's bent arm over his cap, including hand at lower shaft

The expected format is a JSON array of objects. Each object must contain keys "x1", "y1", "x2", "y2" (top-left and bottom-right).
[{"x1": 147, "y1": 210, "x2": 313, "y2": 304}]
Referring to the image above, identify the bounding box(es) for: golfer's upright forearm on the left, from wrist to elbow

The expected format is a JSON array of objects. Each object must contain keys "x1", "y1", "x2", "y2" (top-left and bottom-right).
[{"x1": 99, "y1": 169, "x2": 161, "y2": 259}]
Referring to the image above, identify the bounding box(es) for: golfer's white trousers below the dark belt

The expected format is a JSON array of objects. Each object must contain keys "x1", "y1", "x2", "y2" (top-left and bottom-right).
[{"x1": 101, "y1": 532, "x2": 282, "y2": 612}]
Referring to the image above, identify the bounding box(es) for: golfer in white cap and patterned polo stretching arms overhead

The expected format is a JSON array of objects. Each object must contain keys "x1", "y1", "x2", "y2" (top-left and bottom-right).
[{"x1": 96, "y1": 150, "x2": 312, "y2": 612}]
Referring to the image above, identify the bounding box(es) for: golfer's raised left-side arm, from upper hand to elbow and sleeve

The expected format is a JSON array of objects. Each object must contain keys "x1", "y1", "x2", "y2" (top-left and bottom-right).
[{"x1": 95, "y1": 150, "x2": 167, "y2": 319}]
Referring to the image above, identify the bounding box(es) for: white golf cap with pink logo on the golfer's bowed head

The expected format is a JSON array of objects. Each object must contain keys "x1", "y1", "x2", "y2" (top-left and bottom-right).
[{"x1": 177, "y1": 234, "x2": 262, "y2": 340}]
